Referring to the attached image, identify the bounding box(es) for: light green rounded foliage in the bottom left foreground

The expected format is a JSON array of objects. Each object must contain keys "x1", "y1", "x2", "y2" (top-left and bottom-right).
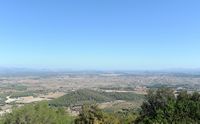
[{"x1": 0, "y1": 102, "x2": 73, "y2": 124}]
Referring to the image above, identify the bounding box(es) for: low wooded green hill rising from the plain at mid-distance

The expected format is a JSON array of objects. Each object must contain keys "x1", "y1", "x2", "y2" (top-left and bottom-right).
[{"x1": 49, "y1": 89, "x2": 144, "y2": 106}]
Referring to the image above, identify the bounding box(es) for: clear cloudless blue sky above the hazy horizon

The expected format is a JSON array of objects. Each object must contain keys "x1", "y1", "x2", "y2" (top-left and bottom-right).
[{"x1": 0, "y1": 0, "x2": 200, "y2": 70}]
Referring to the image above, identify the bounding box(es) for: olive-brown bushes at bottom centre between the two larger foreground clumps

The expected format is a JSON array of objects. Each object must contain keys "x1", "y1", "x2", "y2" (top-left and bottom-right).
[{"x1": 75, "y1": 105, "x2": 137, "y2": 124}]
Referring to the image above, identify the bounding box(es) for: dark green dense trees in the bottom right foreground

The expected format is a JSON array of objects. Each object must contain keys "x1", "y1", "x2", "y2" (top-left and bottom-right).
[{"x1": 136, "y1": 88, "x2": 200, "y2": 124}]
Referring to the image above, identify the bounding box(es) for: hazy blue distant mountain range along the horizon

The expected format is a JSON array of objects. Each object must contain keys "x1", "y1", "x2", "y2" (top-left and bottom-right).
[{"x1": 0, "y1": 67, "x2": 200, "y2": 76}]
